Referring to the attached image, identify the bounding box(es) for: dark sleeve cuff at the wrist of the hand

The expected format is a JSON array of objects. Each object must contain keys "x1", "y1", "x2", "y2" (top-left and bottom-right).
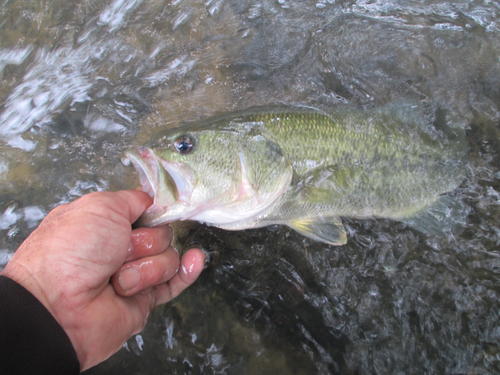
[{"x1": 0, "y1": 276, "x2": 80, "y2": 375}]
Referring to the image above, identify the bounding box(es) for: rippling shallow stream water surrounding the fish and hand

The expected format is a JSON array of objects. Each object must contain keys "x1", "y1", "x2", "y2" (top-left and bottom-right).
[{"x1": 0, "y1": 0, "x2": 500, "y2": 374}]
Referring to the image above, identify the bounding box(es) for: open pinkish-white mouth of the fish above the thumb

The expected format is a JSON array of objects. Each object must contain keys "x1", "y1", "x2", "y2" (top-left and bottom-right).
[{"x1": 125, "y1": 147, "x2": 178, "y2": 207}]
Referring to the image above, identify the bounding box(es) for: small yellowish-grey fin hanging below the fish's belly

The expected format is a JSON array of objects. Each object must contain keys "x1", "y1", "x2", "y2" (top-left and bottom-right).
[{"x1": 287, "y1": 217, "x2": 347, "y2": 246}]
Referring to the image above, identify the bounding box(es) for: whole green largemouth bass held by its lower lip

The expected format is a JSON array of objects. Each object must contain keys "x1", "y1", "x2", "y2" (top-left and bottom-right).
[{"x1": 126, "y1": 105, "x2": 467, "y2": 246}]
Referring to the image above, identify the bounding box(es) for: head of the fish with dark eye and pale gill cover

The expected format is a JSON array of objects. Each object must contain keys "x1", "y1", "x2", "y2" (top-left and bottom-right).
[{"x1": 134, "y1": 128, "x2": 293, "y2": 226}]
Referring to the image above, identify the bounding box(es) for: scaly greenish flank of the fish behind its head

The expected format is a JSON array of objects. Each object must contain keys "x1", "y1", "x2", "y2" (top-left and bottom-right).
[{"x1": 244, "y1": 110, "x2": 463, "y2": 218}]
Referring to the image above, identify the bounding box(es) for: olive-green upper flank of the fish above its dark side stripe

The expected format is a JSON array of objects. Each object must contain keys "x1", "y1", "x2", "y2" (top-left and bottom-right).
[{"x1": 246, "y1": 114, "x2": 454, "y2": 187}]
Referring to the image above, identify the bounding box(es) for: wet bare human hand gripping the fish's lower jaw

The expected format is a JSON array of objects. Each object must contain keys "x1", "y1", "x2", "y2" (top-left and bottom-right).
[{"x1": 2, "y1": 191, "x2": 205, "y2": 371}]
